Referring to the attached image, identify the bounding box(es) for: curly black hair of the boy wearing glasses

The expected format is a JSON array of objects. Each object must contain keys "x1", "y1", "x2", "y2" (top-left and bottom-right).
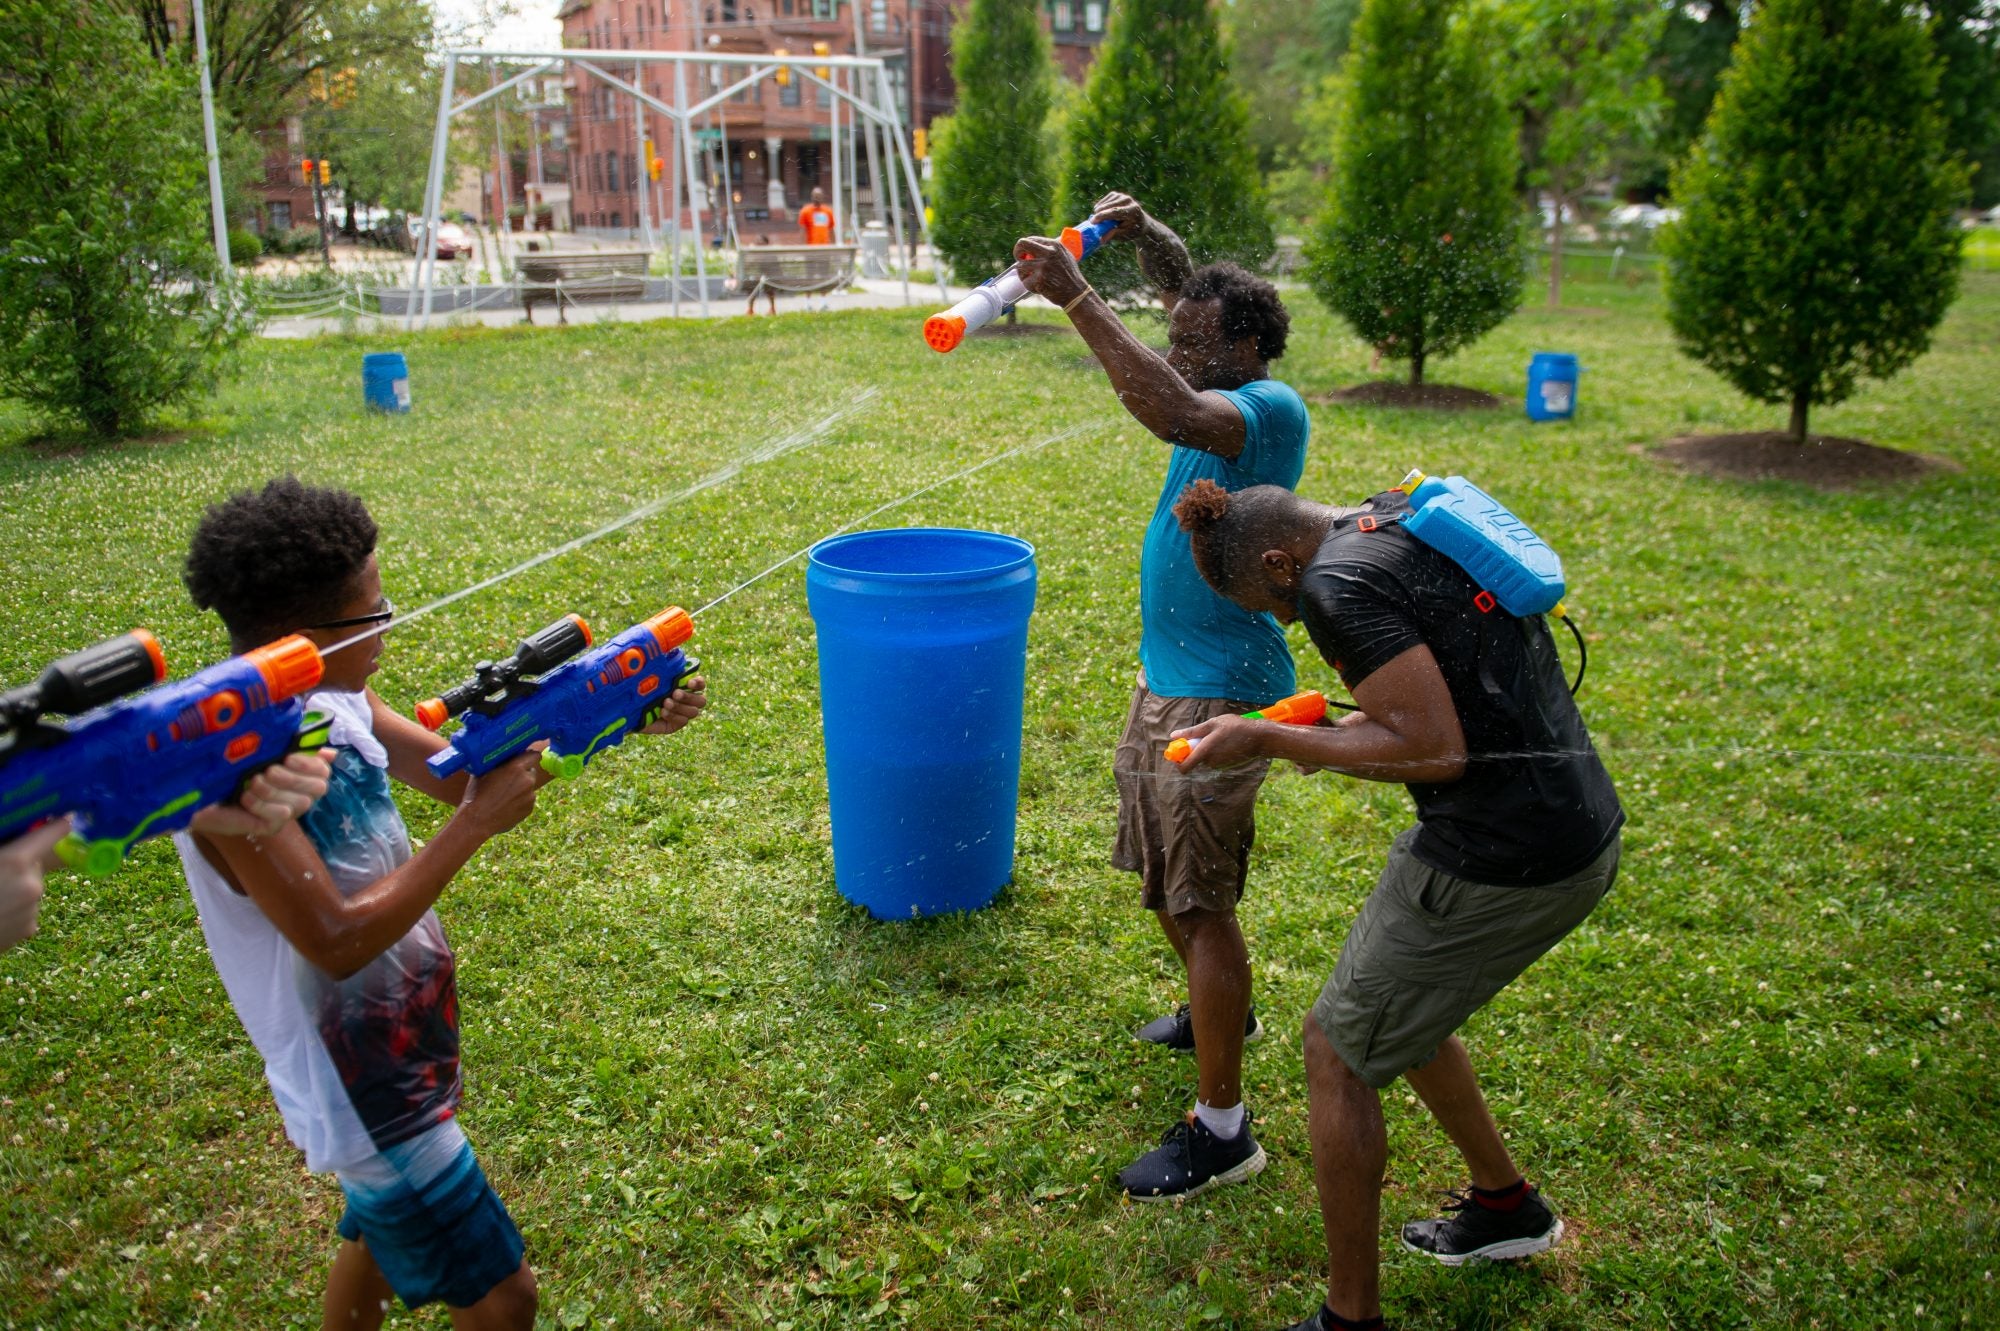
[{"x1": 184, "y1": 476, "x2": 376, "y2": 646}]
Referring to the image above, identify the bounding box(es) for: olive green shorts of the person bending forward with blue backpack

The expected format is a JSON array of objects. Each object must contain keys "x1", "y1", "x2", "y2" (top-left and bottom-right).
[{"x1": 1312, "y1": 827, "x2": 1620, "y2": 1089}]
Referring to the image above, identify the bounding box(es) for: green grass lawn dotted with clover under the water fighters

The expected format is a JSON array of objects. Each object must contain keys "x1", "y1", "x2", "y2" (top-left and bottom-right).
[{"x1": 0, "y1": 274, "x2": 2000, "y2": 1331}]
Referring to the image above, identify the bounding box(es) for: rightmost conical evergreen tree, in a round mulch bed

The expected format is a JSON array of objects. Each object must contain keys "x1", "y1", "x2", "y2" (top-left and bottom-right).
[{"x1": 1662, "y1": 0, "x2": 1966, "y2": 440}]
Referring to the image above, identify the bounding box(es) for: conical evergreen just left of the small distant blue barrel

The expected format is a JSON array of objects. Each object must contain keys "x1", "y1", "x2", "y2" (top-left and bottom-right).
[{"x1": 1306, "y1": 0, "x2": 1528, "y2": 384}]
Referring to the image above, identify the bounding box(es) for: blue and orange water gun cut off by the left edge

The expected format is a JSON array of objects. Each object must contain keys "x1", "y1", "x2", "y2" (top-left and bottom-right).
[{"x1": 0, "y1": 630, "x2": 328, "y2": 873}]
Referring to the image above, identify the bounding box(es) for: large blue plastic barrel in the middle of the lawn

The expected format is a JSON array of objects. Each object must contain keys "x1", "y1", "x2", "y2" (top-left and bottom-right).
[{"x1": 806, "y1": 528, "x2": 1034, "y2": 919}]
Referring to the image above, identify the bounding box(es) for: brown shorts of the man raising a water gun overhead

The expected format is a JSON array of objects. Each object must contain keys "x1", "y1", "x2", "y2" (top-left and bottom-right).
[{"x1": 1112, "y1": 681, "x2": 1270, "y2": 915}]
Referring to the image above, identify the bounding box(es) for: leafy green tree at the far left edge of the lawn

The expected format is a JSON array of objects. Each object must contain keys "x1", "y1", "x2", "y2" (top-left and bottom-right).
[{"x1": 0, "y1": 0, "x2": 244, "y2": 438}]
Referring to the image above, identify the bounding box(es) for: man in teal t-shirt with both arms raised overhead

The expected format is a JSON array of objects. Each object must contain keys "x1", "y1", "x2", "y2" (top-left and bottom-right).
[{"x1": 1014, "y1": 194, "x2": 1310, "y2": 1201}]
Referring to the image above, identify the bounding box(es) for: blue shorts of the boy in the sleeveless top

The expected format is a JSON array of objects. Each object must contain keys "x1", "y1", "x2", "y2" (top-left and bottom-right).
[{"x1": 340, "y1": 1121, "x2": 524, "y2": 1307}]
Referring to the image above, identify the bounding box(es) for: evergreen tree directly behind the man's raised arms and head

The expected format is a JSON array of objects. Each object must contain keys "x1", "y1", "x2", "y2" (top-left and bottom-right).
[{"x1": 1054, "y1": 0, "x2": 1272, "y2": 296}]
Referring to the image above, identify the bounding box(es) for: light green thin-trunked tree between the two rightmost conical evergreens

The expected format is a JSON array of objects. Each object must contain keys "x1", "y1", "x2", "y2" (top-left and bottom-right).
[{"x1": 1494, "y1": 0, "x2": 1666, "y2": 308}]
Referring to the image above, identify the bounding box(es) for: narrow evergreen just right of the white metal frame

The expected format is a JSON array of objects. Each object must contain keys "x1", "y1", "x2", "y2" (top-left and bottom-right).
[{"x1": 930, "y1": 0, "x2": 1056, "y2": 295}]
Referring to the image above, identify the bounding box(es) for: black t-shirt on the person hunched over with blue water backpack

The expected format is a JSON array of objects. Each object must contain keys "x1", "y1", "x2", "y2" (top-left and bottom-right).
[{"x1": 1298, "y1": 496, "x2": 1624, "y2": 887}]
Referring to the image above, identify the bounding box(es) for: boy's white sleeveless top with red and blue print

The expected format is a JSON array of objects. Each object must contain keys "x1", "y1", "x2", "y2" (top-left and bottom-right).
[{"x1": 174, "y1": 691, "x2": 460, "y2": 1173}]
